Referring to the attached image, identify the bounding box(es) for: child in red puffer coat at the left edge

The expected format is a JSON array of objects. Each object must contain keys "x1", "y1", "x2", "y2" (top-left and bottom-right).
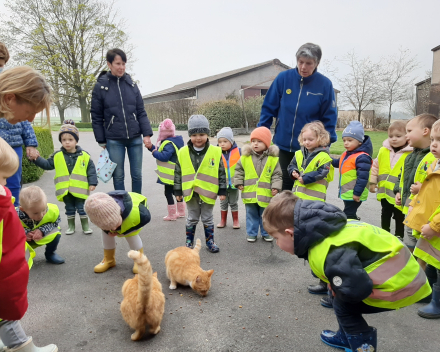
[{"x1": 0, "y1": 138, "x2": 58, "y2": 352}]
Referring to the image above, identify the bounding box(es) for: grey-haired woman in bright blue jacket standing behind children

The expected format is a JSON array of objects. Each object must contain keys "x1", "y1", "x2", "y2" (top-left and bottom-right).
[{"x1": 258, "y1": 43, "x2": 337, "y2": 190}]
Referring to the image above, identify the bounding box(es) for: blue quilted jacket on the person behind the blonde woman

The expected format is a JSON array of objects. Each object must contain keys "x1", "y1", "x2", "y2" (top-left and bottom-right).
[{"x1": 0, "y1": 118, "x2": 38, "y2": 148}]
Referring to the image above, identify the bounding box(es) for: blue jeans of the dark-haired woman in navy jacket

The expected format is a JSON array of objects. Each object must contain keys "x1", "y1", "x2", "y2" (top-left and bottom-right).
[{"x1": 107, "y1": 136, "x2": 143, "y2": 194}]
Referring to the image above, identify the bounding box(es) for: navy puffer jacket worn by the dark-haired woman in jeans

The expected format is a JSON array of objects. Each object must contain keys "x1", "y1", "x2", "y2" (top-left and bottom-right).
[{"x1": 90, "y1": 71, "x2": 153, "y2": 144}]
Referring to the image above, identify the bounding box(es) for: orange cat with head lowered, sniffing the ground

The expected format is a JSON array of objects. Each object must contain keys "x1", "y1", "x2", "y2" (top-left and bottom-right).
[{"x1": 165, "y1": 239, "x2": 214, "y2": 296}]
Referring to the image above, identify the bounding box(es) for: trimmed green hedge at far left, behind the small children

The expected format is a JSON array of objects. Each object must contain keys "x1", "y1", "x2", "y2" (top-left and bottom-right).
[{"x1": 22, "y1": 127, "x2": 54, "y2": 183}]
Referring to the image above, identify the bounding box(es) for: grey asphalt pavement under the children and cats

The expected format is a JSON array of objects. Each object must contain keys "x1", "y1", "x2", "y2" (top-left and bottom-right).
[{"x1": 22, "y1": 132, "x2": 440, "y2": 352}]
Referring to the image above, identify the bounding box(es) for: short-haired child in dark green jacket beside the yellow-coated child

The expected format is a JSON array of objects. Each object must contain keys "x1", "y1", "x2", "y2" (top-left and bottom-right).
[{"x1": 394, "y1": 114, "x2": 438, "y2": 252}]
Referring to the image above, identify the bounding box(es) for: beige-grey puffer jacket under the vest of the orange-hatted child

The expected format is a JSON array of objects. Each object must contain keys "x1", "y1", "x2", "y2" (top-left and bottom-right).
[{"x1": 234, "y1": 144, "x2": 283, "y2": 191}]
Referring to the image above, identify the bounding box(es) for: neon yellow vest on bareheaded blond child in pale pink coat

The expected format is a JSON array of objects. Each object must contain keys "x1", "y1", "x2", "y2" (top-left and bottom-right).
[{"x1": 377, "y1": 147, "x2": 411, "y2": 205}]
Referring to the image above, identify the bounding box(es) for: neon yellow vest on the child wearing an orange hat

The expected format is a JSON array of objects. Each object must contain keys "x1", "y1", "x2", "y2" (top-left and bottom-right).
[{"x1": 241, "y1": 155, "x2": 279, "y2": 208}]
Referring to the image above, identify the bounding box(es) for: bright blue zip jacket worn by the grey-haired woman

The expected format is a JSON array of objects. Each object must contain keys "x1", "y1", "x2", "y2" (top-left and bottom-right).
[{"x1": 258, "y1": 68, "x2": 337, "y2": 152}]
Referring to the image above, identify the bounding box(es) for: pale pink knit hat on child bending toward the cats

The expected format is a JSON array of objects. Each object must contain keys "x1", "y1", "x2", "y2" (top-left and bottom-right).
[{"x1": 84, "y1": 192, "x2": 122, "y2": 231}]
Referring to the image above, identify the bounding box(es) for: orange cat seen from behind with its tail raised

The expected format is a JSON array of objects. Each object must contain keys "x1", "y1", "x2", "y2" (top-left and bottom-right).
[{"x1": 121, "y1": 251, "x2": 165, "y2": 341}]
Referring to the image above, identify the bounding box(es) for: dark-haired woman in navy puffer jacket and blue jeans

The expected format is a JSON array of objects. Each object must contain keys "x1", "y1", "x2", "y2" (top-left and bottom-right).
[{"x1": 90, "y1": 49, "x2": 153, "y2": 193}]
